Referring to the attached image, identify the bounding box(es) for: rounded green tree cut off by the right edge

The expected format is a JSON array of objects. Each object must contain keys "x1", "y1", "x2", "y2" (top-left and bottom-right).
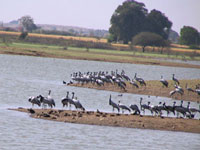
[{"x1": 180, "y1": 26, "x2": 200, "y2": 45}]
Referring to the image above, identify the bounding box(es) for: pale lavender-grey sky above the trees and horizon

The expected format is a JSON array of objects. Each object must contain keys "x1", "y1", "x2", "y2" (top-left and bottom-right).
[{"x1": 0, "y1": 0, "x2": 200, "y2": 33}]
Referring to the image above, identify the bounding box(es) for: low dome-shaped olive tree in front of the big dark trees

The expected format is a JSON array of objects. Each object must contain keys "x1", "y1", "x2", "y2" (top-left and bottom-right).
[{"x1": 132, "y1": 32, "x2": 168, "y2": 52}]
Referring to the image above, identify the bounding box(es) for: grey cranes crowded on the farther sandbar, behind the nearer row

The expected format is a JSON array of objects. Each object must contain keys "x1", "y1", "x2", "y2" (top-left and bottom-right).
[{"x1": 67, "y1": 70, "x2": 200, "y2": 96}]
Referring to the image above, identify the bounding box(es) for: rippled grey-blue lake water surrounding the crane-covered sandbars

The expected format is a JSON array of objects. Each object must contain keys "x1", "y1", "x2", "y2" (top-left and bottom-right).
[{"x1": 0, "y1": 55, "x2": 200, "y2": 150}]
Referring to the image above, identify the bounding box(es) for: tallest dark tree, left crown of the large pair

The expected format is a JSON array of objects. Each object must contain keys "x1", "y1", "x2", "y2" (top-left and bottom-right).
[{"x1": 109, "y1": 0, "x2": 147, "y2": 43}]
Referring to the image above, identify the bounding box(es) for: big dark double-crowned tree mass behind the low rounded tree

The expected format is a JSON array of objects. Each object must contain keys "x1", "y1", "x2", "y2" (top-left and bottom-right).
[{"x1": 109, "y1": 0, "x2": 172, "y2": 43}]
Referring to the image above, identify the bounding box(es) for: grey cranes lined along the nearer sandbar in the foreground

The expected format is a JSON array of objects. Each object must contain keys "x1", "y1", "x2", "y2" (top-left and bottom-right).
[{"x1": 28, "y1": 90, "x2": 200, "y2": 118}]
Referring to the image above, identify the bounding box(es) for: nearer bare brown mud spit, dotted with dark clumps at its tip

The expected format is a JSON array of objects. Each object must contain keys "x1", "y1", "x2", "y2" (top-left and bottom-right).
[{"x1": 9, "y1": 108, "x2": 200, "y2": 133}]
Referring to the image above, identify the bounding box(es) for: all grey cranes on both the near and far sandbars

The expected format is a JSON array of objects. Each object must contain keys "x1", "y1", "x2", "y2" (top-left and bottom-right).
[{"x1": 28, "y1": 70, "x2": 200, "y2": 118}]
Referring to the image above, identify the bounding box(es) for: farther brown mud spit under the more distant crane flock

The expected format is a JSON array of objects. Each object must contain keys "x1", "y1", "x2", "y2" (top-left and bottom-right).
[{"x1": 70, "y1": 79, "x2": 200, "y2": 102}]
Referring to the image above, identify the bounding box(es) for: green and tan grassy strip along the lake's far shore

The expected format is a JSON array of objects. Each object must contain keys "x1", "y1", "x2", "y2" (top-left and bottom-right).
[{"x1": 0, "y1": 43, "x2": 200, "y2": 68}]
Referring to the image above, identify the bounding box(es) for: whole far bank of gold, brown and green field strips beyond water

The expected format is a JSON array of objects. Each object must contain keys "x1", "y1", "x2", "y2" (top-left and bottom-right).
[{"x1": 0, "y1": 31, "x2": 200, "y2": 68}]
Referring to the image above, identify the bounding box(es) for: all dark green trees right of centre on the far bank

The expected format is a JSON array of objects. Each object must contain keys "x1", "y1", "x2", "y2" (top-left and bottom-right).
[{"x1": 108, "y1": 0, "x2": 200, "y2": 51}]
